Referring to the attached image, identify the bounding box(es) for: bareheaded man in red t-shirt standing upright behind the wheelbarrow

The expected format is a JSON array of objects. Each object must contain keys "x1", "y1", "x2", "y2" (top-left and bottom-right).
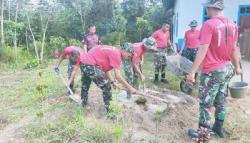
[{"x1": 152, "y1": 23, "x2": 171, "y2": 83}]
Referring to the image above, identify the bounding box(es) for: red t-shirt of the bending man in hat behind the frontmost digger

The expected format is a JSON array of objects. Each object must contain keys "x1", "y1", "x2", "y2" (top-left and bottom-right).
[{"x1": 132, "y1": 42, "x2": 147, "y2": 63}]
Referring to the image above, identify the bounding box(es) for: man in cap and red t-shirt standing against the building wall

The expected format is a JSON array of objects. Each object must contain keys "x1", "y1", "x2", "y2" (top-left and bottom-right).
[{"x1": 181, "y1": 20, "x2": 200, "y2": 62}]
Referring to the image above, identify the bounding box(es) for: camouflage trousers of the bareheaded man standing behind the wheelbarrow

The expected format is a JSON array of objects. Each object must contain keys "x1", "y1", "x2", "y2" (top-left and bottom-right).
[{"x1": 154, "y1": 48, "x2": 167, "y2": 74}]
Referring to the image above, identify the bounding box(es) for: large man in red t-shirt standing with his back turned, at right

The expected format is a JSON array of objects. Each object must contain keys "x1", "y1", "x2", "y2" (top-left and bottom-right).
[{"x1": 187, "y1": 0, "x2": 242, "y2": 138}]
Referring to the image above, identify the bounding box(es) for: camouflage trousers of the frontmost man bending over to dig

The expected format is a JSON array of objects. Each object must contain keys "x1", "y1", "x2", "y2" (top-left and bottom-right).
[{"x1": 81, "y1": 64, "x2": 112, "y2": 110}]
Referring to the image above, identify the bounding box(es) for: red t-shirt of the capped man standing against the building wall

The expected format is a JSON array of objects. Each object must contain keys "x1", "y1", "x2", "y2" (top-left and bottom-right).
[{"x1": 185, "y1": 30, "x2": 200, "y2": 49}]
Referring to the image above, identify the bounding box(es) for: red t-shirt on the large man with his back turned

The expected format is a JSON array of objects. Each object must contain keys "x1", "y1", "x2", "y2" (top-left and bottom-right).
[{"x1": 200, "y1": 17, "x2": 238, "y2": 73}]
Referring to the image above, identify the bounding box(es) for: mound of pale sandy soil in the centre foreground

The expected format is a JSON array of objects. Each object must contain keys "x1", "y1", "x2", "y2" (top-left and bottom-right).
[{"x1": 118, "y1": 90, "x2": 198, "y2": 142}]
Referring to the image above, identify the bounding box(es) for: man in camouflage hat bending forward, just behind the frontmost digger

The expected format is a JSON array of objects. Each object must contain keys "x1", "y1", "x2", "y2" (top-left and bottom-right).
[{"x1": 122, "y1": 37, "x2": 156, "y2": 98}]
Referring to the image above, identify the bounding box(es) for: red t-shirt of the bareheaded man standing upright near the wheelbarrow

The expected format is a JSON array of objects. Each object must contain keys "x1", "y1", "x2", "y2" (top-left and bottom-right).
[{"x1": 152, "y1": 29, "x2": 170, "y2": 49}]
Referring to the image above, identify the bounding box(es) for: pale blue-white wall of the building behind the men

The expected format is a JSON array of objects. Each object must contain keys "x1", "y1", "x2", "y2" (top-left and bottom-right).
[{"x1": 173, "y1": 0, "x2": 250, "y2": 48}]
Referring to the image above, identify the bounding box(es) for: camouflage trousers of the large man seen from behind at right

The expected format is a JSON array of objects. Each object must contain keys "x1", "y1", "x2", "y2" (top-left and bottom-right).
[{"x1": 199, "y1": 64, "x2": 234, "y2": 127}]
